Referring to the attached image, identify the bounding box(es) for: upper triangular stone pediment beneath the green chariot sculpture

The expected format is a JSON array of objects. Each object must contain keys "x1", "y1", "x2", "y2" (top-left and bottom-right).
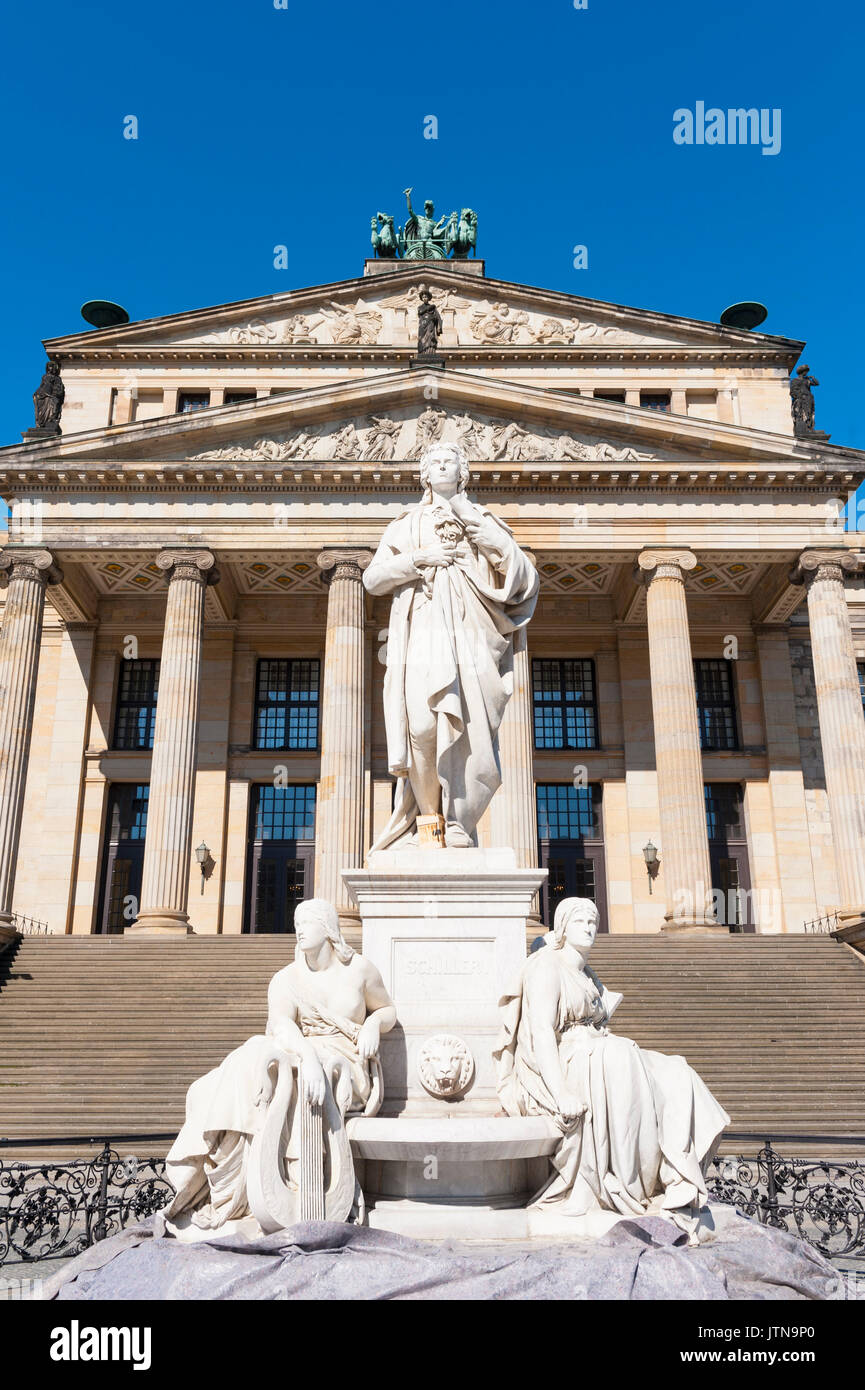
[{"x1": 46, "y1": 263, "x2": 802, "y2": 361}]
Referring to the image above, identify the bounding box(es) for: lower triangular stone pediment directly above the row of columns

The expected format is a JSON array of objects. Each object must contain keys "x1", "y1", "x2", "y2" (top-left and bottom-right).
[{"x1": 3, "y1": 370, "x2": 855, "y2": 467}]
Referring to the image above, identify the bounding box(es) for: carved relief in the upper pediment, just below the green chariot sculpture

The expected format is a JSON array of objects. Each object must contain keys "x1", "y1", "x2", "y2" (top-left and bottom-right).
[{"x1": 161, "y1": 281, "x2": 669, "y2": 348}]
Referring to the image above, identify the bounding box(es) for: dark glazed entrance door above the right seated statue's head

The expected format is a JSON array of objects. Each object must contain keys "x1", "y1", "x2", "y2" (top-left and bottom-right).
[{"x1": 537, "y1": 784, "x2": 609, "y2": 931}]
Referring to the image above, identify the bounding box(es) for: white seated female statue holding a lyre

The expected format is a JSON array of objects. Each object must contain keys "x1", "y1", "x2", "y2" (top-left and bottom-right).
[{"x1": 163, "y1": 898, "x2": 396, "y2": 1240}]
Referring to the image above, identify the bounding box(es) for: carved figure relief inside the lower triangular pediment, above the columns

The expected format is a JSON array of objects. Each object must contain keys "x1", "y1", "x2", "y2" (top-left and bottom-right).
[{"x1": 184, "y1": 406, "x2": 659, "y2": 463}]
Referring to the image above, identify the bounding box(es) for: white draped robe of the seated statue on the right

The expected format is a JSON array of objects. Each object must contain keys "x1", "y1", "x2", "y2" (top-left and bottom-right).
[{"x1": 494, "y1": 945, "x2": 730, "y2": 1229}]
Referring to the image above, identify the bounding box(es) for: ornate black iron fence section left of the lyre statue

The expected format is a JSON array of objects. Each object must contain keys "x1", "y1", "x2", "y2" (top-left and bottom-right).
[{"x1": 0, "y1": 1134, "x2": 174, "y2": 1265}]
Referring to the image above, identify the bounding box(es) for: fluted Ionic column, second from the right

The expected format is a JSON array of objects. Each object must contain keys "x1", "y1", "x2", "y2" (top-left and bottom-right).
[{"x1": 637, "y1": 550, "x2": 719, "y2": 931}]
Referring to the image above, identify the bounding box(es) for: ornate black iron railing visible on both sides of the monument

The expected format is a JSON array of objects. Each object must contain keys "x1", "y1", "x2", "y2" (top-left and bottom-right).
[{"x1": 0, "y1": 1130, "x2": 865, "y2": 1265}]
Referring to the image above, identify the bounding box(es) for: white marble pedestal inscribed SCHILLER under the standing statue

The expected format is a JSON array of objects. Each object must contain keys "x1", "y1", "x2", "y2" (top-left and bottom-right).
[{"x1": 343, "y1": 849, "x2": 547, "y2": 1116}]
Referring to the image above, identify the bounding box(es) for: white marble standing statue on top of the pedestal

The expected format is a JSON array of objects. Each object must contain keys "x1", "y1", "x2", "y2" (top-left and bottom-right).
[{"x1": 363, "y1": 443, "x2": 538, "y2": 849}]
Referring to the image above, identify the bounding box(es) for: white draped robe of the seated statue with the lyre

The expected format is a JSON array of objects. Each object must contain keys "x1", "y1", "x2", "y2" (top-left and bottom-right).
[{"x1": 164, "y1": 952, "x2": 370, "y2": 1230}]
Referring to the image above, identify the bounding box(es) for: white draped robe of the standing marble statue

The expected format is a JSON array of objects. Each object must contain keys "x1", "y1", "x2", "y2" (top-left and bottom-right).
[{"x1": 363, "y1": 498, "x2": 538, "y2": 849}]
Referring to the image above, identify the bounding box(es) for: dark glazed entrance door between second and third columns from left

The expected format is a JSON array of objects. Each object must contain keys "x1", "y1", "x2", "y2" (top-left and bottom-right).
[{"x1": 243, "y1": 785, "x2": 316, "y2": 933}]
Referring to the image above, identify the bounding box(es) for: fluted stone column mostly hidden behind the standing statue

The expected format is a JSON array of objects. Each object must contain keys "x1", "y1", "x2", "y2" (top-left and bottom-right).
[{"x1": 490, "y1": 628, "x2": 538, "y2": 869}]
